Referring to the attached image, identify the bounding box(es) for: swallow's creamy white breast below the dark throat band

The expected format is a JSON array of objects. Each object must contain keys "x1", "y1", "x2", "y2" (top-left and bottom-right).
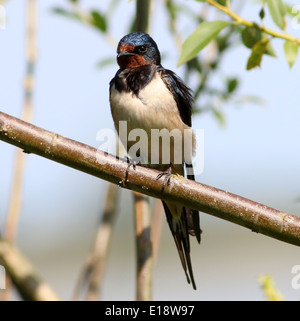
[{"x1": 110, "y1": 73, "x2": 192, "y2": 166}]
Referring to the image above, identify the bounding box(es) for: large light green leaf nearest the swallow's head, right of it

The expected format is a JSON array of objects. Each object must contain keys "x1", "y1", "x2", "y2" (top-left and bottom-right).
[{"x1": 178, "y1": 20, "x2": 231, "y2": 66}]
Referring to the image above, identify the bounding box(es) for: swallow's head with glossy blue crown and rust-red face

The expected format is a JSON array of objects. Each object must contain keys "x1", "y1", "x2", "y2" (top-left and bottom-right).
[{"x1": 117, "y1": 32, "x2": 160, "y2": 68}]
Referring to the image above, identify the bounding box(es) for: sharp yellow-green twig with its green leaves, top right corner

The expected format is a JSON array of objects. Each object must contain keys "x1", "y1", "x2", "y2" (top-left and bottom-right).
[{"x1": 178, "y1": 0, "x2": 300, "y2": 70}]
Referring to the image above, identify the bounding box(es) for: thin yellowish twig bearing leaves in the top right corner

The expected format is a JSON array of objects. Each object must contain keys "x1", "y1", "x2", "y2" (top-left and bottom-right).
[{"x1": 205, "y1": 0, "x2": 300, "y2": 45}]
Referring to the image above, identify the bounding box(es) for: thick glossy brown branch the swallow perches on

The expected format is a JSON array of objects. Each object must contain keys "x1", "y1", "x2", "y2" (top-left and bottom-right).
[{"x1": 0, "y1": 112, "x2": 300, "y2": 246}]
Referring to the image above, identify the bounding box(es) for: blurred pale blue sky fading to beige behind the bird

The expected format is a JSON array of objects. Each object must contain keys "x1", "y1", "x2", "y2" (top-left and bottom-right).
[{"x1": 0, "y1": 0, "x2": 300, "y2": 300}]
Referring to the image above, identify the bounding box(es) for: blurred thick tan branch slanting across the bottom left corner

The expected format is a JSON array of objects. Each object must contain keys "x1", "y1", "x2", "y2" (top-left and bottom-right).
[{"x1": 0, "y1": 239, "x2": 60, "y2": 301}]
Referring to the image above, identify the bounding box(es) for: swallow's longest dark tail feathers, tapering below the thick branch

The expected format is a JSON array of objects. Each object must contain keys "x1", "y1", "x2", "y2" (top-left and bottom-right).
[{"x1": 162, "y1": 201, "x2": 196, "y2": 290}]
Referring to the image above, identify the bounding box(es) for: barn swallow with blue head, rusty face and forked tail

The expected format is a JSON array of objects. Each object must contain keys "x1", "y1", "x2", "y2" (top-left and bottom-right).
[{"x1": 109, "y1": 32, "x2": 202, "y2": 290}]
